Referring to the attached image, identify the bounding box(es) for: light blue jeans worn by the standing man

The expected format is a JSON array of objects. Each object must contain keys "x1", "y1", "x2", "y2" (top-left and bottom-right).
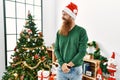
[{"x1": 57, "y1": 66, "x2": 82, "y2": 80}]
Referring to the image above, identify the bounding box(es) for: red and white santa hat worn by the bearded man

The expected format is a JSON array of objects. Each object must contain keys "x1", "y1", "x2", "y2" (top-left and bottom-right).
[{"x1": 63, "y1": 2, "x2": 78, "y2": 19}]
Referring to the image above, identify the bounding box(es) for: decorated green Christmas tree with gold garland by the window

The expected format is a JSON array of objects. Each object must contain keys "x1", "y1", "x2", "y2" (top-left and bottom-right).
[{"x1": 2, "y1": 12, "x2": 52, "y2": 80}]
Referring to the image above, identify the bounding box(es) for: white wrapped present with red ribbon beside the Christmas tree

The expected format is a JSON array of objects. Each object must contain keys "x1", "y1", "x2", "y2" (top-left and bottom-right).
[{"x1": 38, "y1": 70, "x2": 50, "y2": 80}]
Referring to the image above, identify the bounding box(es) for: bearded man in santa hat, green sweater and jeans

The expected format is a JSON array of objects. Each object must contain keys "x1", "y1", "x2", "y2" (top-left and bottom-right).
[{"x1": 54, "y1": 2, "x2": 88, "y2": 80}]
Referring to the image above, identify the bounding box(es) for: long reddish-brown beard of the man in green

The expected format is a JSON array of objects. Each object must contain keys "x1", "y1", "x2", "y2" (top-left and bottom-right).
[{"x1": 59, "y1": 18, "x2": 72, "y2": 36}]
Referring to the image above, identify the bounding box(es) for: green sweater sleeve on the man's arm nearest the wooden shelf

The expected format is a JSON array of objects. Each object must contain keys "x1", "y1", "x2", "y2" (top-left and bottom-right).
[{"x1": 72, "y1": 29, "x2": 88, "y2": 65}]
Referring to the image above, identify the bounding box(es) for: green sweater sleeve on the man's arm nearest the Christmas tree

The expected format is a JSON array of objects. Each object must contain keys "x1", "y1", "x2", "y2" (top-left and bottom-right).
[{"x1": 54, "y1": 32, "x2": 64, "y2": 66}]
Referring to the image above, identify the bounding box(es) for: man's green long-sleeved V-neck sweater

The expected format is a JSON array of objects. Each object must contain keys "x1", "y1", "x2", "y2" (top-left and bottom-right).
[{"x1": 54, "y1": 25, "x2": 88, "y2": 67}]
